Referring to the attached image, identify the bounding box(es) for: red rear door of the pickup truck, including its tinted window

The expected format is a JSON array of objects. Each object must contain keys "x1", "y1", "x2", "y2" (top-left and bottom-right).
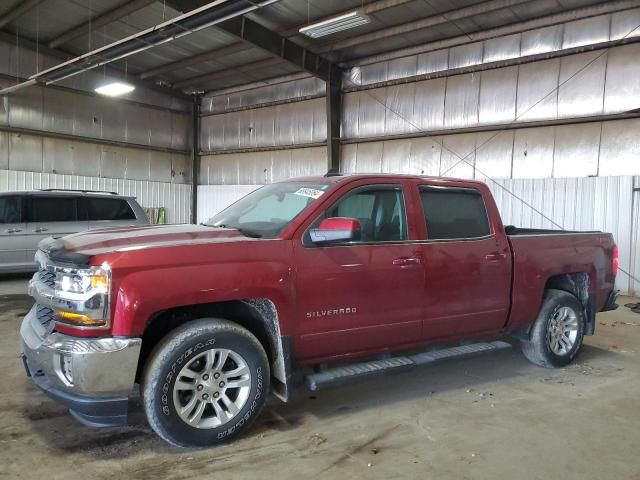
[{"x1": 419, "y1": 185, "x2": 511, "y2": 339}]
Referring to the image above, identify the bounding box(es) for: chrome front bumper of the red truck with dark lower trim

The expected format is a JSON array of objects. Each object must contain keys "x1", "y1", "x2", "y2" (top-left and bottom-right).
[{"x1": 20, "y1": 305, "x2": 142, "y2": 426}]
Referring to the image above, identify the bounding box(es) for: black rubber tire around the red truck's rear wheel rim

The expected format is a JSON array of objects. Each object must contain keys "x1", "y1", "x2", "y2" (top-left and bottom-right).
[{"x1": 522, "y1": 289, "x2": 585, "y2": 368}]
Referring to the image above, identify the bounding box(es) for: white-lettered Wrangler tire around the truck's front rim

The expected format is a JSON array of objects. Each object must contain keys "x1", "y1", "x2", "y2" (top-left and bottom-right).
[{"x1": 141, "y1": 318, "x2": 270, "y2": 447}]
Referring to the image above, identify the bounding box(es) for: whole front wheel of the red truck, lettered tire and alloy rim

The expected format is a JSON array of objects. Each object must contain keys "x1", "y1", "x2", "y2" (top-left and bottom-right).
[{"x1": 142, "y1": 319, "x2": 270, "y2": 447}]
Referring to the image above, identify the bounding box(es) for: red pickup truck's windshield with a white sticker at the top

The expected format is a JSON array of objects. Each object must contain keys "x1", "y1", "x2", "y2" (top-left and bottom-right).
[{"x1": 203, "y1": 182, "x2": 329, "y2": 238}]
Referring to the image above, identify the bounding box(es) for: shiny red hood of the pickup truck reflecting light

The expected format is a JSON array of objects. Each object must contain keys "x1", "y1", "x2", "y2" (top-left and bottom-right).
[{"x1": 52, "y1": 225, "x2": 252, "y2": 256}]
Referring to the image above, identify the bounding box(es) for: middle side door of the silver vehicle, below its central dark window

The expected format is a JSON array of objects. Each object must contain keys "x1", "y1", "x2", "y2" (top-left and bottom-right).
[{"x1": 27, "y1": 195, "x2": 88, "y2": 257}]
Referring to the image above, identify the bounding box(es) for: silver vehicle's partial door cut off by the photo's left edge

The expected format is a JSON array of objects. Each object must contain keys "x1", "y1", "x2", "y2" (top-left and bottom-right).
[{"x1": 0, "y1": 194, "x2": 28, "y2": 272}]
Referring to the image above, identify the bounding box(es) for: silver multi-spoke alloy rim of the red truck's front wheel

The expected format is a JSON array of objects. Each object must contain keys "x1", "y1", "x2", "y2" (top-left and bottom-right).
[{"x1": 173, "y1": 348, "x2": 251, "y2": 429}]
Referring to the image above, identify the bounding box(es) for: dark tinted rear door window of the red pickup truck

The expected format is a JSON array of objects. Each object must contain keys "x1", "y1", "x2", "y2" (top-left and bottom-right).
[{"x1": 420, "y1": 187, "x2": 491, "y2": 240}]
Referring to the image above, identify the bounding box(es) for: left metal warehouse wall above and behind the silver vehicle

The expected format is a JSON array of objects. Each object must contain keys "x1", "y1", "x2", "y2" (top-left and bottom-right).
[{"x1": 0, "y1": 42, "x2": 191, "y2": 223}]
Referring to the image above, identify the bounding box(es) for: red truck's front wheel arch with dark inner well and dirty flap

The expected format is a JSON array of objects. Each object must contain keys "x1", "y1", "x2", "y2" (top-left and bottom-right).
[{"x1": 141, "y1": 298, "x2": 292, "y2": 402}]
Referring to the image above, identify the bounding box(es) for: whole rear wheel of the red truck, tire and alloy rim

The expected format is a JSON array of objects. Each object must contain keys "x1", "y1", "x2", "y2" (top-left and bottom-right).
[{"x1": 522, "y1": 290, "x2": 585, "y2": 368}]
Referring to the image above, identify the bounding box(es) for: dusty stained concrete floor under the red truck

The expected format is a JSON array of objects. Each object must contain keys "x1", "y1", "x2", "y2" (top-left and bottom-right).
[{"x1": 0, "y1": 279, "x2": 640, "y2": 480}]
